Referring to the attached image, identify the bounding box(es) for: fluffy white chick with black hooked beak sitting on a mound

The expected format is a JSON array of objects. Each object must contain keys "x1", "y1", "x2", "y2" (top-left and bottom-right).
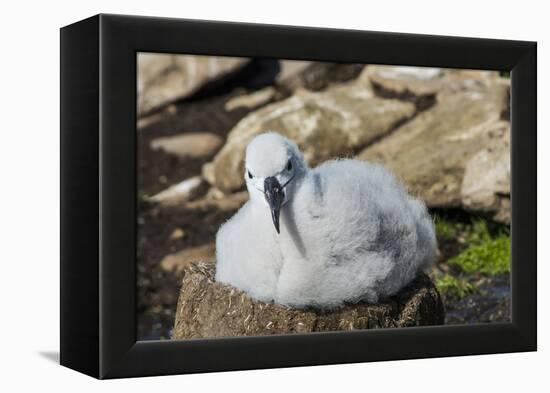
[{"x1": 216, "y1": 132, "x2": 436, "y2": 308}]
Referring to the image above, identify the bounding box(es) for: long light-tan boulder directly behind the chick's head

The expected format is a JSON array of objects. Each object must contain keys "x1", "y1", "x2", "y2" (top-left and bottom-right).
[{"x1": 208, "y1": 82, "x2": 415, "y2": 192}]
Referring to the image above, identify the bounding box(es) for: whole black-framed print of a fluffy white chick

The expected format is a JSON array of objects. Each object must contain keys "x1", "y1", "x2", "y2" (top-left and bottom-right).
[{"x1": 61, "y1": 15, "x2": 537, "y2": 378}]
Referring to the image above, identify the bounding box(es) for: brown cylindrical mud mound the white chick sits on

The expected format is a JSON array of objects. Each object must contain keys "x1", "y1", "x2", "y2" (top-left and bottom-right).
[{"x1": 172, "y1": 263, "x2": 445, "y2": 339}]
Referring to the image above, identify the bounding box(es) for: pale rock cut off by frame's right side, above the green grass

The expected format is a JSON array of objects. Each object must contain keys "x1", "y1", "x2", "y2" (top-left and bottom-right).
[{"x1": 460, "y1": 122, "x2": 511, "y2": 223}]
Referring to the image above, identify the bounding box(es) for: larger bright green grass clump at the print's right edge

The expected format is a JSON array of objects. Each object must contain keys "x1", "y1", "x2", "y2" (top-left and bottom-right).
[{"x1": 449, "y1": 235, "x2": 510, "y2": 275}]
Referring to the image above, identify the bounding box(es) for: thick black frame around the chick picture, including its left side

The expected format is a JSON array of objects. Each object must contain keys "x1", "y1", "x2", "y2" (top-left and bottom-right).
[{"x1": 61, "y1": 15, "x2": 537, "y2": 378}]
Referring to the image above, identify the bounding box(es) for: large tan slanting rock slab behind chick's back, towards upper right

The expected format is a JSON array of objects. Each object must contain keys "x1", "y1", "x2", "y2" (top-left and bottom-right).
[{"x1": 358, "y1": 83, "x2": 509, "y2": 211}]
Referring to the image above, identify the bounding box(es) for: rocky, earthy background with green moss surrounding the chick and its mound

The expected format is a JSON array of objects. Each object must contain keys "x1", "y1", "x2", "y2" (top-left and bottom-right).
[{"x1": 136, "y1": 54, "x2": 510, "y2": 340}]
